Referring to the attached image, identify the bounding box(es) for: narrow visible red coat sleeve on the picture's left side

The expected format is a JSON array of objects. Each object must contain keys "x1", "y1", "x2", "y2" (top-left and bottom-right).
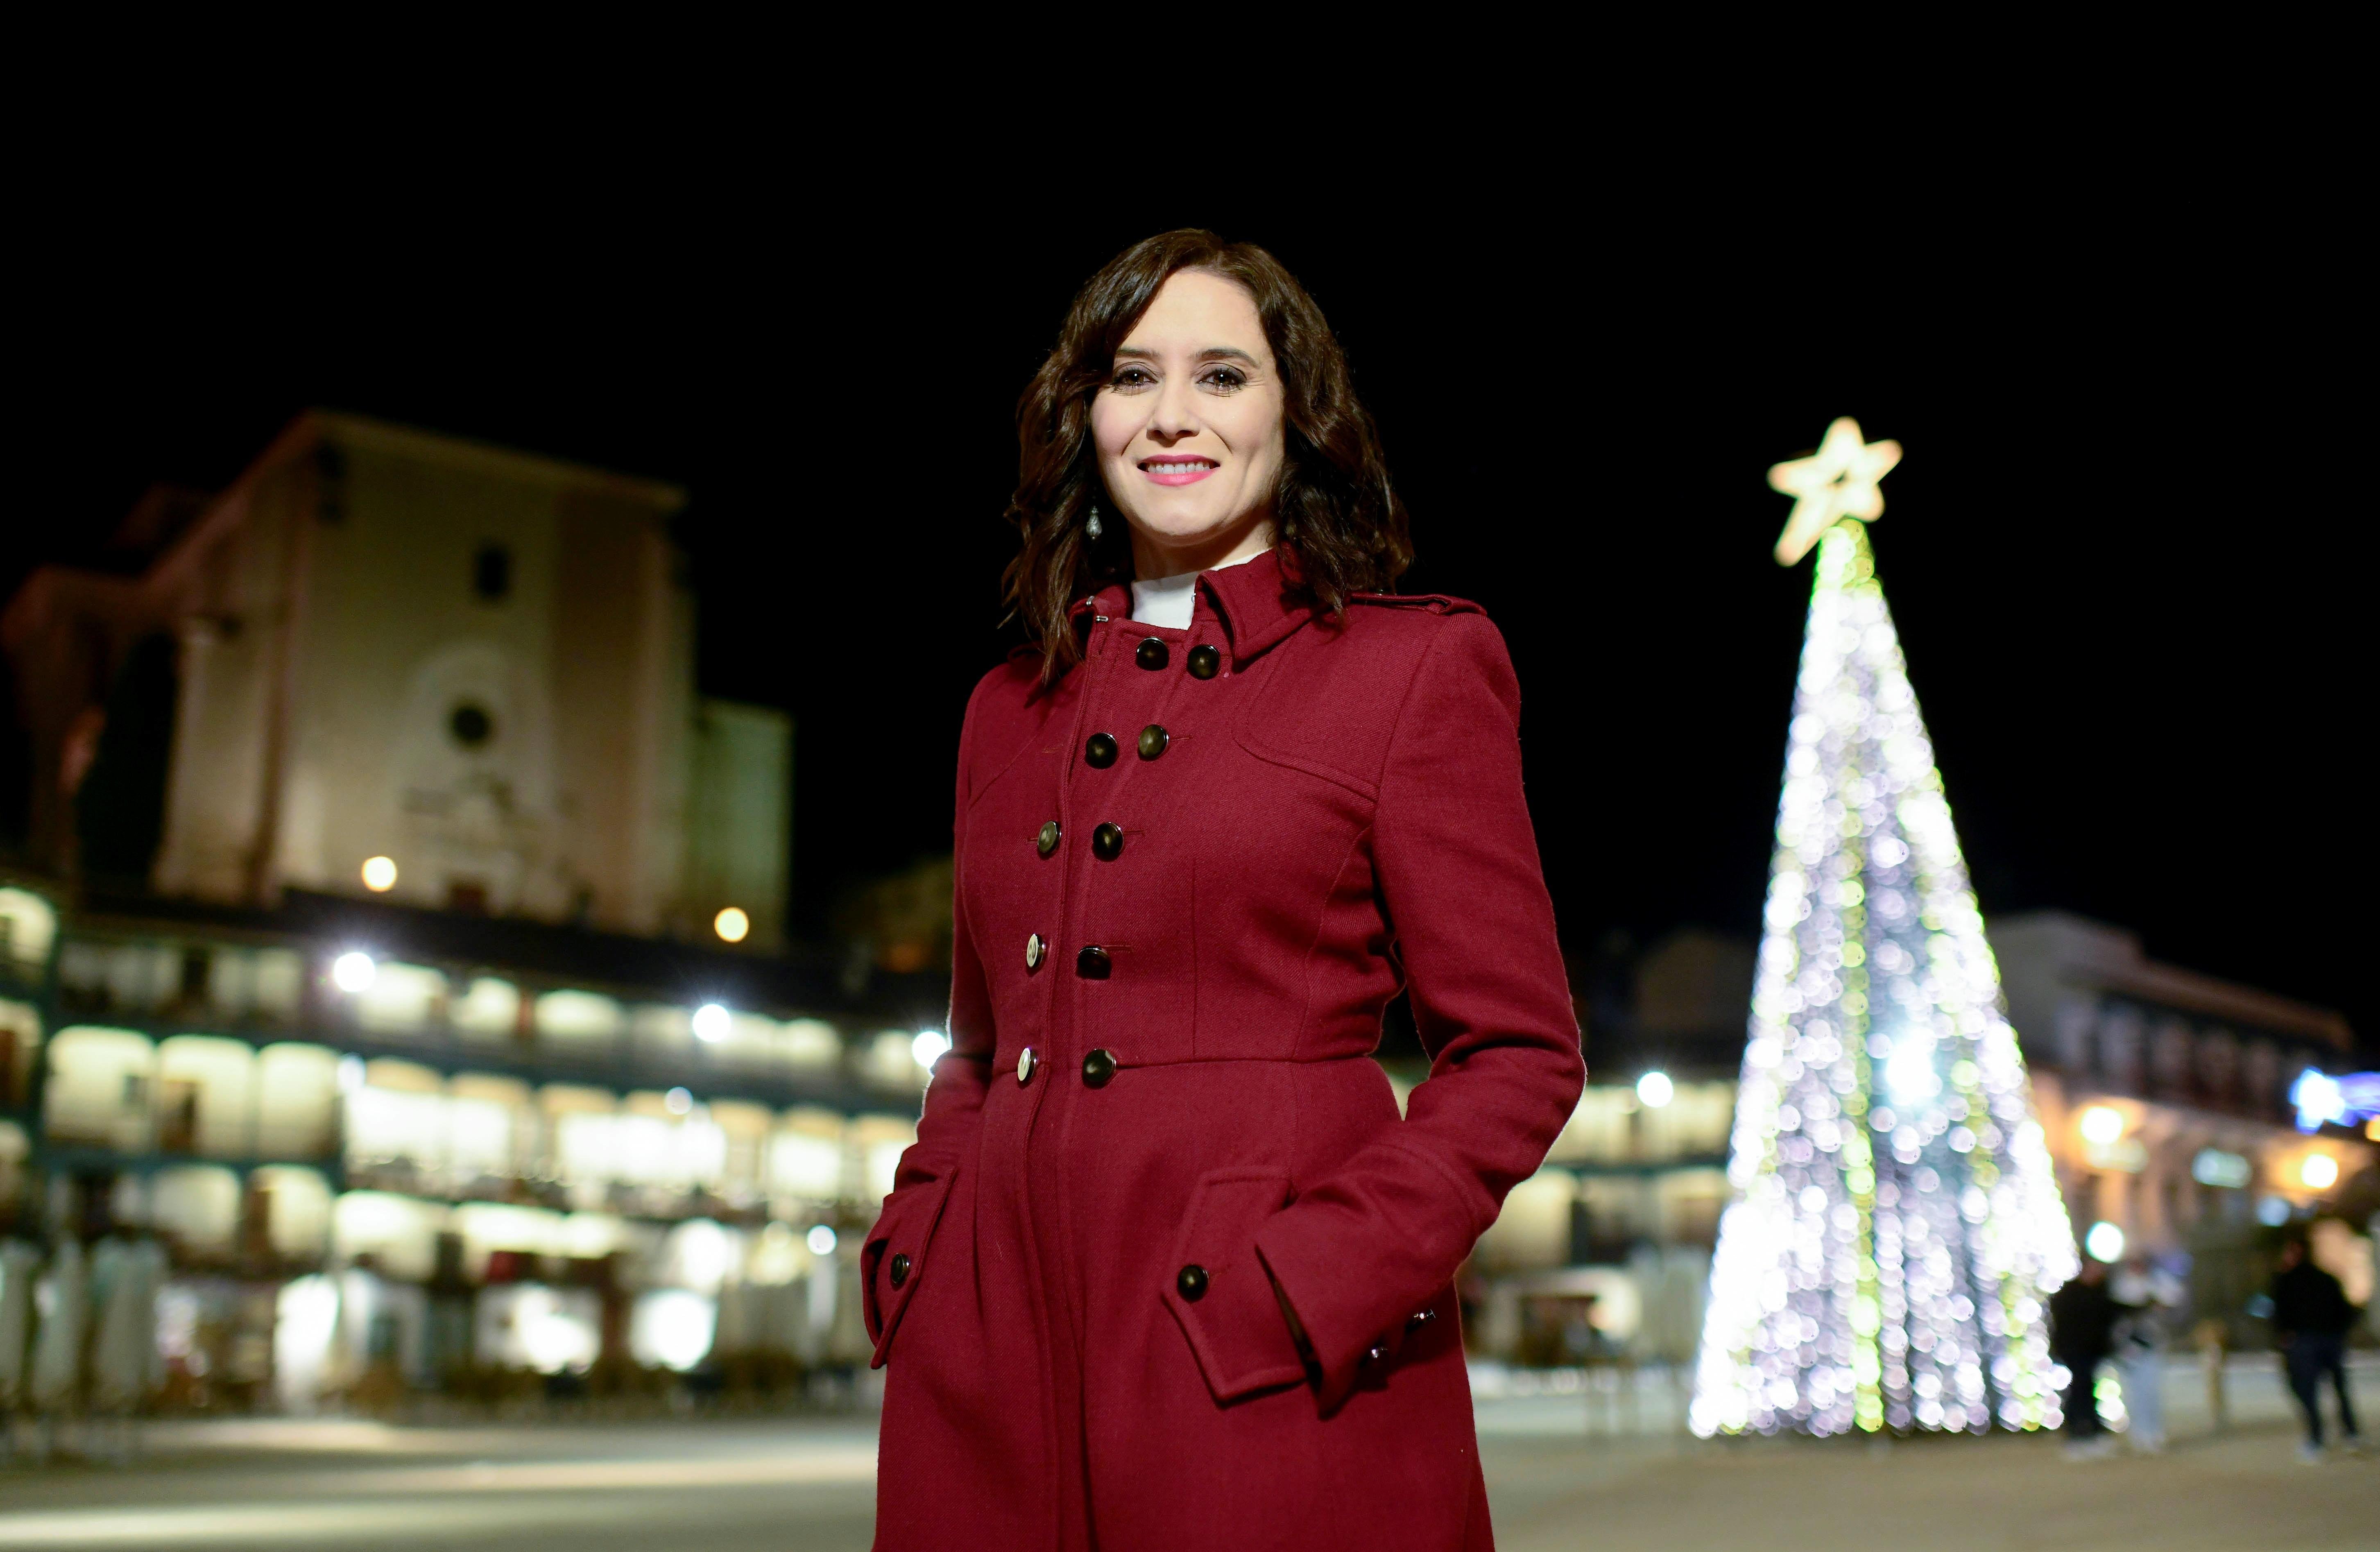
[{"x1": 859, "y1": 678, "x2": 995, "y2": 1364}]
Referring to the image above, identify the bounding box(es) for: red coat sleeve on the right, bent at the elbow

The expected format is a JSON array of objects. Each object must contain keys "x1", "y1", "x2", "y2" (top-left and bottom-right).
[{"x1": 1257, "y1": 614, "x2": 1585, "y2": 1409}]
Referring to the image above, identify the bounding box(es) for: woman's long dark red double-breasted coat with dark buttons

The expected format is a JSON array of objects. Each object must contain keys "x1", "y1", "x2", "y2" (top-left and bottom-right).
[{"x1": 862, "y1": 555, "x2": 1585, "y2": 1552}]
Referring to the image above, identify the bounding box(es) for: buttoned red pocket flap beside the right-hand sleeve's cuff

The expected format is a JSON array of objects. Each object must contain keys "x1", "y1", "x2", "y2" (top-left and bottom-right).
[{"x1": 1162, "y1": 1169, "x2": 1307, "y2": 1402}]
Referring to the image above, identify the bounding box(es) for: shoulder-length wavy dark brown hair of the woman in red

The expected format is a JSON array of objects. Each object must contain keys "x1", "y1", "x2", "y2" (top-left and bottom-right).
[{"x1": 1002, "y1": 229, "x2": 1414, "y2": 681}]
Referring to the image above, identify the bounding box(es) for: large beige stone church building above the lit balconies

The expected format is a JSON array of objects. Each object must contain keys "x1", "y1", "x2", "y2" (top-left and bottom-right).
[{"x1": 0, "y1": 412, "x2": 793, "y2": 950}]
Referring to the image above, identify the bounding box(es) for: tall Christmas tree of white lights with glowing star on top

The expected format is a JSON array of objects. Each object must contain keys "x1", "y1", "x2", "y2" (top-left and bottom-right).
[{"x1": 1690, "y1": 419, "x2": 2075, "y2": 1438}]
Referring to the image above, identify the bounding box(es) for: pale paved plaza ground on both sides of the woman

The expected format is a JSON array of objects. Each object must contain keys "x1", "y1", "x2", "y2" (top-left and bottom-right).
[{"x1": 0, "y1": 1359, "x2": 2380, "y2": 1552}]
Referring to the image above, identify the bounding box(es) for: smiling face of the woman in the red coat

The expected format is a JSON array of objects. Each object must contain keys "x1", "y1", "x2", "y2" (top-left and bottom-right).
[{"x1": 1090, "y1": 269, "x2": 1283, "y2": 578}]
